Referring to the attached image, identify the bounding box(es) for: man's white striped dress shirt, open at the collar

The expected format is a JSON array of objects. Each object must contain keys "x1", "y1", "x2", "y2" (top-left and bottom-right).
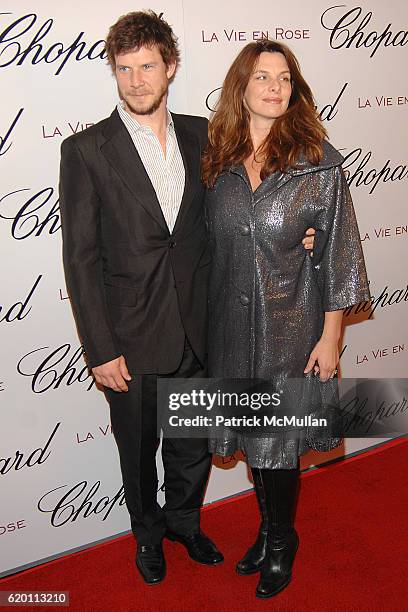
[{"x1": 117, "y1": 102, "x2": 186, "y2": 233}]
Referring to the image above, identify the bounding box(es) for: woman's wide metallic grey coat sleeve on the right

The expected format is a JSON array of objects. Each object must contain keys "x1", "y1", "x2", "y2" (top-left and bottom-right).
[{"x1": 313, "y1": 166, "x2": 370, "y2": 312}]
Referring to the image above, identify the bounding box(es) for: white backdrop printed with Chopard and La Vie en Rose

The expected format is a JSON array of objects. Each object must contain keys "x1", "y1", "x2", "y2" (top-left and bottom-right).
[{"x1": 0, "y1": 0, "x2": 408, "y2": 576}]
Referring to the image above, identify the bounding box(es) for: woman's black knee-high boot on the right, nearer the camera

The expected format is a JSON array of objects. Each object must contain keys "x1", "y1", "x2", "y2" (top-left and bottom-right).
[{"x1": 256, "y1": 467, "x2": 299, "y2": 598}]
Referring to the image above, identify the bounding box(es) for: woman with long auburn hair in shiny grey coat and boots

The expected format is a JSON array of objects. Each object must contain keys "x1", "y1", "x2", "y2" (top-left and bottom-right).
[{"x1": 203, "y1": 40, "x2": 369, "y2": 597}]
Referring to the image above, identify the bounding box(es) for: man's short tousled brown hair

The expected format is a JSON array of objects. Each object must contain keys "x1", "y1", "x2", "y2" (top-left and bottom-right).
[{"x1": 106, "y1": 11, "x2": 180, "y2": 70}]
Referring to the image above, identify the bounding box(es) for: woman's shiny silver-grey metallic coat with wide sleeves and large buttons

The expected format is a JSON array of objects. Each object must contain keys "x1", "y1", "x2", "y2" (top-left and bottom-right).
[{"x1": 206, "y1": 142, "x2": 370, "y2": 468}]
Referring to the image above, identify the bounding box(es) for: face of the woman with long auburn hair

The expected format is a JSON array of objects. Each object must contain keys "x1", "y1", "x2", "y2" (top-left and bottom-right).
[{"x1": 243, "y1": 51, "x2": 292, "y2": 127}]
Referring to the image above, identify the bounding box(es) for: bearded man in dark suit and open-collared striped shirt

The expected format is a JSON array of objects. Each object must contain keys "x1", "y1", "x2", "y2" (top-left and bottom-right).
[{"x1": 60, "y1": 11, "x2": 316, "y2": 584}]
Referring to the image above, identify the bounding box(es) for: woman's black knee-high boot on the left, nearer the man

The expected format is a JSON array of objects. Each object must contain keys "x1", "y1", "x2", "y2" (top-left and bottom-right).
[{"x1": 236, "y1": 468, "x2": 268, "y2": 576}]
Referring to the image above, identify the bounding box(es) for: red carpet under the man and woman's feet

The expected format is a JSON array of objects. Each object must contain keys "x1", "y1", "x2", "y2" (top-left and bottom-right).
[{"x1": 0, "y1": 440, "x2": 408, "y2": 612}]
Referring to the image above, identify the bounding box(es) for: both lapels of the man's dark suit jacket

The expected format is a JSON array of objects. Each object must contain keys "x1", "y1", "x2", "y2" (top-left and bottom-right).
[{"x1": 100, "y1": 109, "x2": 200, "y2": 234}]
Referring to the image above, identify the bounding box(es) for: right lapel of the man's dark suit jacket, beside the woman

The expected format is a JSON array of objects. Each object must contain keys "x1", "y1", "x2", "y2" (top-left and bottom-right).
[{"x1": 172, "y1": 114, "x2": 201, "y2": 233}]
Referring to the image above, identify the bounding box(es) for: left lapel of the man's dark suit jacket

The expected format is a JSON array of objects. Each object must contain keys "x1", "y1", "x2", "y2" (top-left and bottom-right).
[{"x1": 101, "y1": 109, "x2": 169, "y2": 233}]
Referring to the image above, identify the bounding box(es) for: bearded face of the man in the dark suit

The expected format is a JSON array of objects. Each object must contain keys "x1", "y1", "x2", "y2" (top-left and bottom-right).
[{"x1": 115, "y1": 47, "x2": 176, "y2": 116}]
